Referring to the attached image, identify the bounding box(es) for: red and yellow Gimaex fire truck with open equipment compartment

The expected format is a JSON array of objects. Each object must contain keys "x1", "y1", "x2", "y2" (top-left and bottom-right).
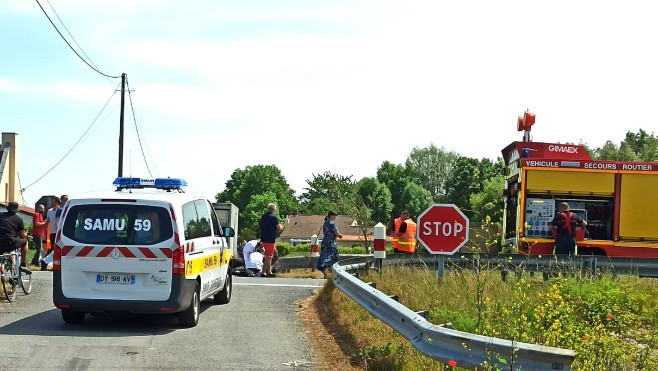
[{"x1": 502, "y1": 112, "x2": 658, "y2": 257}]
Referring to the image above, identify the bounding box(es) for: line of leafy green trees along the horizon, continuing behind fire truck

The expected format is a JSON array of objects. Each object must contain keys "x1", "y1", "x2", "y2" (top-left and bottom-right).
[{"x1": 216, "y1": 129, "x2": 658, "y2": 240}]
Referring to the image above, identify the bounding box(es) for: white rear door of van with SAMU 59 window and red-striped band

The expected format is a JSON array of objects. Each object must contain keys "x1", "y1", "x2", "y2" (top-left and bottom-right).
[{"x1": 59, "y1": 199, "x2": 175, "y2": 301}]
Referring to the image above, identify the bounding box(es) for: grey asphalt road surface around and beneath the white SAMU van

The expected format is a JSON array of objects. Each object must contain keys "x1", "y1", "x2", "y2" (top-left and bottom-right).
[{"x1": 0, "y1": 272, "x2": 324, "y2": 370}]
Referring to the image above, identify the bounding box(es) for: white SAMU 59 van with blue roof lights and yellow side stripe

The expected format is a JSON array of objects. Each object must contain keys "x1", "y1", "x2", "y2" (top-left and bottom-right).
[{"x1": 53, "y1": 177, "x2": 235, "y2": 327}]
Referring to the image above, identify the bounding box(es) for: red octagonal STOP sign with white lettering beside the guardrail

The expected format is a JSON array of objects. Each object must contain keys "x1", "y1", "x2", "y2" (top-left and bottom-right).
[{"x1": 416, "y1": 204, "x2": 469, "y2": 255}]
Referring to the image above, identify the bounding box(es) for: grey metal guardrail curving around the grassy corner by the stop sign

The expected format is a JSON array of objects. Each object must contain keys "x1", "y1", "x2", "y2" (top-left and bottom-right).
[{"x1": 277, "y1": 253, "x2": 658, "y2": 370}]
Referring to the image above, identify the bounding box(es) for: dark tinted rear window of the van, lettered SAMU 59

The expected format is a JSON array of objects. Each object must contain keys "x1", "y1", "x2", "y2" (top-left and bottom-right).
[{"x1": 62, "y1": 204, "x2": 173, "y2": 246}]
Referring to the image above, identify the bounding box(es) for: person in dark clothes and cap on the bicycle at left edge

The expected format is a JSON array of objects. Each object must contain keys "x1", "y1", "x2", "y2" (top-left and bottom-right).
[{"x1": 0, "y1": 201, "x2": 32, "y2": 274}]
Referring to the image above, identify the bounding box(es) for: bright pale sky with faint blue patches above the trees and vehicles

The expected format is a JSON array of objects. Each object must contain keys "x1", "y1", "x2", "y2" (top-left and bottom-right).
[{"x1": 0, "y1": 0, "x2": 658, "y2": 206}]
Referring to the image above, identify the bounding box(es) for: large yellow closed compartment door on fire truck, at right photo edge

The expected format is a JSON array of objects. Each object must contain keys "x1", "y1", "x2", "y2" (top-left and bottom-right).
[{"x1": 619, "y1": 174, "x2": 658, "y2": 240}]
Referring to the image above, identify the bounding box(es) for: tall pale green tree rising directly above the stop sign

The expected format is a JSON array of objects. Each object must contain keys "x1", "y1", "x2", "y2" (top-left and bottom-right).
[{"x1": 406, "y1": 144, "x2": 459, "y2": 202}]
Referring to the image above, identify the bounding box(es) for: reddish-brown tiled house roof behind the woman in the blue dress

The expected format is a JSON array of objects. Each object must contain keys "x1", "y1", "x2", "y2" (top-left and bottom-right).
[{"x1": 279, "y1": 215, "x2": 382, "y2": 241}]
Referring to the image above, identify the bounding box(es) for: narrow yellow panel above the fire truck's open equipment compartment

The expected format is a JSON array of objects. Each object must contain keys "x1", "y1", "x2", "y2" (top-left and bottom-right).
[{"x1": 526, "y1": 170, "x2": 615, "y2": 196}]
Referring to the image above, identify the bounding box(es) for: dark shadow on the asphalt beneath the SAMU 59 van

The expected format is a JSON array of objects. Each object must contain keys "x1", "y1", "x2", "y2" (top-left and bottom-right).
[{"x1": 0, "y1": 301, "x2": 213, "y2": 337}]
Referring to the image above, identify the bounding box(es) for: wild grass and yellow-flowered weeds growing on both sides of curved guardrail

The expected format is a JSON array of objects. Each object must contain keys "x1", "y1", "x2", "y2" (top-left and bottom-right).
[{"x1": 317, "y1": 266, "x2": 658, "y2": 371}]
